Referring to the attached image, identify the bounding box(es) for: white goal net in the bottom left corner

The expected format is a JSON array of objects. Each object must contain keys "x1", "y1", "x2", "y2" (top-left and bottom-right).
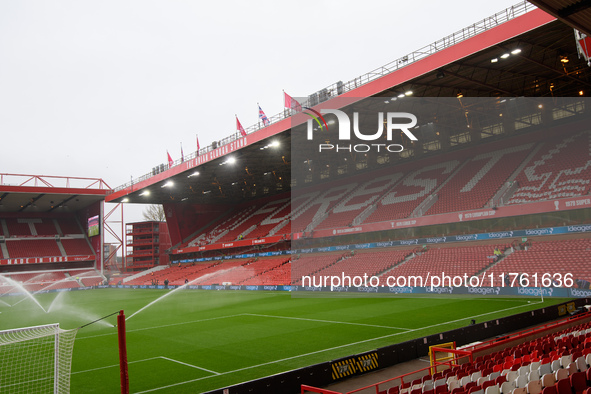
[{"x1": 0, "y1": 324, "x2": 78, "y2": 394}]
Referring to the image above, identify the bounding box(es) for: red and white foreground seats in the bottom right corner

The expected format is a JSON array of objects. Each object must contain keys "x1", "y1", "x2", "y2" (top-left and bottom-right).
[{"x1": 378, "y1": 323, "x2": 591, "y2": 394}]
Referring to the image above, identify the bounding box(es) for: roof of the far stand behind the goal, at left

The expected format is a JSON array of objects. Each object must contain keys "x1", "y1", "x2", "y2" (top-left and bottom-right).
[{"x1": 0, "y1": 174, "x2": 111, "y2": 214}]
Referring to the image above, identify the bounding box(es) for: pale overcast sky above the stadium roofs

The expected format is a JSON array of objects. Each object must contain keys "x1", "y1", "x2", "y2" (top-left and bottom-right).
[{"x1": 0, "y1": 0, "x2": 528, "y2": 223}]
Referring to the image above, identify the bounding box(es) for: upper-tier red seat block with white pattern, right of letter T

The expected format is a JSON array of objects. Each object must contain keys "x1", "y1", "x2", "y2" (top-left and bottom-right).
[{"x1": 508, "y1": 131, "x2": 591, "y2": 204}]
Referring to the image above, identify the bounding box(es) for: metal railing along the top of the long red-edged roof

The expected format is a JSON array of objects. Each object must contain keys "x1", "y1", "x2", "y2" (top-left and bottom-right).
[{"x1": 114, "y1": 1, "x2": 536, "y2": 191}]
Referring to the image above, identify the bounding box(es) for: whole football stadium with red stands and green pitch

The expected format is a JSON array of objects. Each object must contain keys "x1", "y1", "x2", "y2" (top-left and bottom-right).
[{"x1": 0, "y1": 0, "x2": 591, "y2": 394}]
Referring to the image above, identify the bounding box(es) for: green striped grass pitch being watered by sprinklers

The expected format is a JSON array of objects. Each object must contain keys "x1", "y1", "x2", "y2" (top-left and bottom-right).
[{"x1": 0, "y1": 289, "x2": 564, "y2": 393}]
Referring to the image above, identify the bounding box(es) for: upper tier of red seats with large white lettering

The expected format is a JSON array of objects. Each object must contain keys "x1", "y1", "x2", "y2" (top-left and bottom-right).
[{"x1": 179, "y1": 130, "x2": 591, "y2": 246}]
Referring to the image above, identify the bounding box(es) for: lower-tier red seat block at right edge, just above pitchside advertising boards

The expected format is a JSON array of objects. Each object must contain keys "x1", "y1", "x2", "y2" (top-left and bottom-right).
[{"x1": 486, "y1": 239, "x2": 591, "y2": 287}]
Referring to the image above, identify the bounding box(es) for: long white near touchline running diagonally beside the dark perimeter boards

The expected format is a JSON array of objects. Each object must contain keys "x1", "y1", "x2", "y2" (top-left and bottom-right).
[{"x1": 135, "y1": 301, "x2": 542, "y2": 394}]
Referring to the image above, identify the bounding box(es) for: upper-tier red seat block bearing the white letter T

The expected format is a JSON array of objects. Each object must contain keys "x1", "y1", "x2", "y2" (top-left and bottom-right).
[{"x1": 427, "y1": 144, "x2": 533, "y2": 215}]
